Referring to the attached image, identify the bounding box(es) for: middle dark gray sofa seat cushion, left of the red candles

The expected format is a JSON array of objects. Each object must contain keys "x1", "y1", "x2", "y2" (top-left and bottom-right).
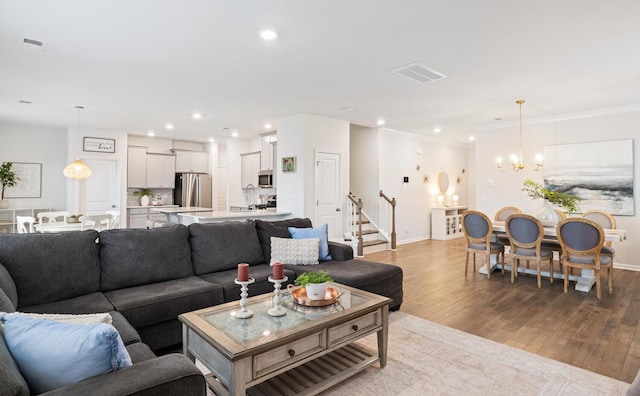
[{"x1": 105, "y1": 276, "x2": 223, "y2": 328}]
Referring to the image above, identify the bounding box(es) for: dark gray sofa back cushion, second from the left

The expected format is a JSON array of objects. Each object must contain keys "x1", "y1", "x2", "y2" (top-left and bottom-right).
[{"x1": 100, "y1": 225, "x2": 193, "y2": 291}]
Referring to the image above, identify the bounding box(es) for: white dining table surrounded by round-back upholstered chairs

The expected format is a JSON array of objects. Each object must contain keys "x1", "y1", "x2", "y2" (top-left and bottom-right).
[{"x1": 478, "y1": 221, "x2": 627, "y2": 293}]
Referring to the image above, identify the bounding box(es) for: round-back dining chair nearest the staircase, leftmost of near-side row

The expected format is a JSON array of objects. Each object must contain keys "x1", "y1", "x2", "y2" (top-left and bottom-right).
[{"x1": 462, "y1": 210, "x2": 504, "y2": 279}]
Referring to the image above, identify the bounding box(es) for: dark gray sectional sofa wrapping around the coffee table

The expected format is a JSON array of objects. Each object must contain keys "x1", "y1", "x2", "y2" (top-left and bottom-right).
[{"x1": 0, "y1": 219, "x2": 402, "y2": 395}]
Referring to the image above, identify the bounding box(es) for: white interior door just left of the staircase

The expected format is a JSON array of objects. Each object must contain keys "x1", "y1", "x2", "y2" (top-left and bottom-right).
[{"x1": 314, "y1": 152, "x2": 342, "y2": 238}]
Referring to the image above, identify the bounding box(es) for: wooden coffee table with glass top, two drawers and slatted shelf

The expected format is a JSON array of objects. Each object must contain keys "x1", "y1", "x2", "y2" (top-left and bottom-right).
[{"x1": 179, "y1": 283, "x2": 391, "y2": 395}]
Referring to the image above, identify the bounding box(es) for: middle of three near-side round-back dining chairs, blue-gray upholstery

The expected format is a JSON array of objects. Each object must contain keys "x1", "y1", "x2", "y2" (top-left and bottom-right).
[{"x1": 505, "y1": 213, "x2": 553, "y2": 288}]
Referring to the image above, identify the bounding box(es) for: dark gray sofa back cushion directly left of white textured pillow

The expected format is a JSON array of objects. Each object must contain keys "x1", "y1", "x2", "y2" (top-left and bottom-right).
[{"x1": 189, "y1": 220, "x2": 268, "y2": 275}]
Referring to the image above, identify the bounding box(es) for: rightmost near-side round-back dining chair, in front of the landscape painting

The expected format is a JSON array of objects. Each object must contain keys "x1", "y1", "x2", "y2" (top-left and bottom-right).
[{"x1": 557, "y1": 217, "x2": 613, "y2": 300}]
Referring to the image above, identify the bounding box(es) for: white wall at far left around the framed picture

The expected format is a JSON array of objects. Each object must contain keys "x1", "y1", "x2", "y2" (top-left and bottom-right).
[{"x1": 0, "y1": 124, "x2": 68, "y2": 210}]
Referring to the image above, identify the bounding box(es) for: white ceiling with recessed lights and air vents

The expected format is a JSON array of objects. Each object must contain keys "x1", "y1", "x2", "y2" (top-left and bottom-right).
[{"x1": 0, "y1": 0, "x2": 640, "y2": 142}]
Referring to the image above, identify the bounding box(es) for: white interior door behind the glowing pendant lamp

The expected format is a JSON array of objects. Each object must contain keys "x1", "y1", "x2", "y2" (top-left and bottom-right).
[{"x1": 80, "y1": 159, "x2": 119, "y2": 214}]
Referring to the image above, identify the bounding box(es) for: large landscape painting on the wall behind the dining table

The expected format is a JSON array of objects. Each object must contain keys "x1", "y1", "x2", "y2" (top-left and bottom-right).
[{"x1": 543, "y1": 140, "x2": 635, "y2": 216}]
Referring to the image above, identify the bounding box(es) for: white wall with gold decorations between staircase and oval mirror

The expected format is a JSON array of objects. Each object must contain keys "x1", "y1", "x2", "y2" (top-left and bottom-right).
[{"x1": 380, "y1": 129, "x2": 470, "y2": 243}]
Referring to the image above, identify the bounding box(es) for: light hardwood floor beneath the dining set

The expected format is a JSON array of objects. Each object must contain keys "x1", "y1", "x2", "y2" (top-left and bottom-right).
[{"x1": 364, "y1": 239, "x2": 640, "y2": 382}]
